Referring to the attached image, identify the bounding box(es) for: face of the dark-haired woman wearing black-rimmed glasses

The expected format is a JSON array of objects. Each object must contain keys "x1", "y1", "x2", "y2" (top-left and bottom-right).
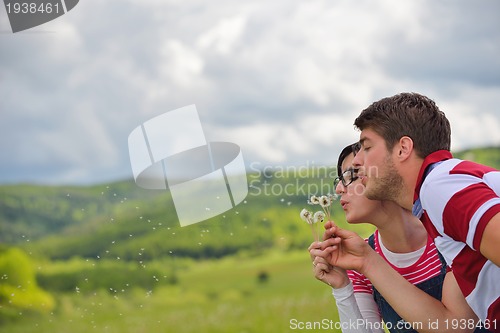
[{"x1": 335, "y1": 154, "x2": 380, "y2": 223}]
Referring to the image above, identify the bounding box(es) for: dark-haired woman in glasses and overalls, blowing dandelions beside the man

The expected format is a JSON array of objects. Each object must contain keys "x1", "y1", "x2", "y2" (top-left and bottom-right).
[{"x1": 309, "y1": 145, "x2": 484, "y2": 332}]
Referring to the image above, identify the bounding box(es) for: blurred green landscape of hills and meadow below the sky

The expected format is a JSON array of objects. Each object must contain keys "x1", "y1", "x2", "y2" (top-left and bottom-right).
[{"x1": 0, "y1": 147, "x2": 500, "y2": 333}]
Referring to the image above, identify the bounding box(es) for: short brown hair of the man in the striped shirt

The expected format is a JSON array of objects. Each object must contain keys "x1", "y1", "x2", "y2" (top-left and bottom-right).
[{"x1": 354, "y1": 93, "x2": 451, "y2": 158}]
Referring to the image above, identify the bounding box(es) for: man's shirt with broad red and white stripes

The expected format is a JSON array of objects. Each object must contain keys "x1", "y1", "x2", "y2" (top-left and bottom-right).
[{"x1": 414, "y1": 150, "x2": 500, "y2": 325}]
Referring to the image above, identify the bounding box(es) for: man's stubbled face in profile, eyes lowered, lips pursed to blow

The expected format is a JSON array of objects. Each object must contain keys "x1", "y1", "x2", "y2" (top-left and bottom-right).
[{"x1": 352, "y1": 129, "x2": 404, "y2": 201}]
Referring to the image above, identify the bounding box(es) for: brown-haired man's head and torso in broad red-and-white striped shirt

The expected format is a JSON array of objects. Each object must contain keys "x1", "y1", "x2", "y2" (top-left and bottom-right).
[{"x1": 346, "y1": 93, "x2": 500, "y2": 331}]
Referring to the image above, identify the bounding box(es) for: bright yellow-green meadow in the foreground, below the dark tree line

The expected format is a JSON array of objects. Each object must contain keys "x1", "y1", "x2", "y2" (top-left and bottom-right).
[{"x1": 1, "y1": 250, "x2": 344, "y2": 333}]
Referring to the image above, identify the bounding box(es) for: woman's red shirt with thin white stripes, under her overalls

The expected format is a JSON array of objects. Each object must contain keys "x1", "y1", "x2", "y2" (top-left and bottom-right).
[{"x1": 347, "y1": 230, "x2": 443, "y2": 294}]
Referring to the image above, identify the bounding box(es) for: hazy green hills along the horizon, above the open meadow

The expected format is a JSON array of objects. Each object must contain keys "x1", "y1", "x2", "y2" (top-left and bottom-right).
[{"x1": 0, "y1": 147, "x2": 500, "y2": 260}]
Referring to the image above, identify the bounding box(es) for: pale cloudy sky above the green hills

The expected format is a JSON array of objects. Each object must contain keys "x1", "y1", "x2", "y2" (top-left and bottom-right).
[{"x1": 0, "y1": 0, "x2": 500, "y2": 184}]
